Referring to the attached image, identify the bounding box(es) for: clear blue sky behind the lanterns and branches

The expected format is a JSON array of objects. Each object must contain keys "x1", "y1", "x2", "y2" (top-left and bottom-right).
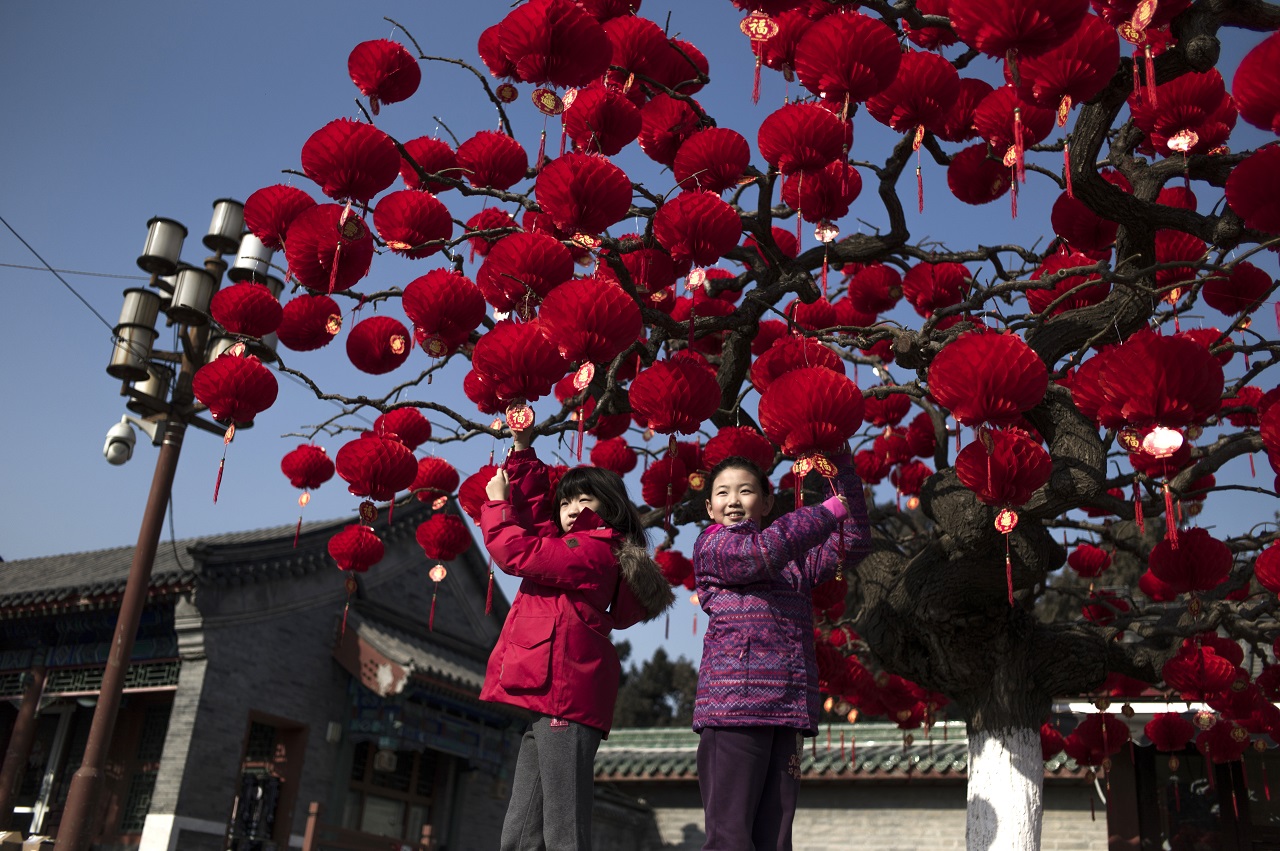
[{"x1": 0, "y1": 0, "x2": 1275, "y2": 659}]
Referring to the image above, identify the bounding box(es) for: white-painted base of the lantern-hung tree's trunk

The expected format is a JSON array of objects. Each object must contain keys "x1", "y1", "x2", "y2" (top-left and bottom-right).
[{"x1": 965, "y1": 727, "x2": 1044, "y2": 851}]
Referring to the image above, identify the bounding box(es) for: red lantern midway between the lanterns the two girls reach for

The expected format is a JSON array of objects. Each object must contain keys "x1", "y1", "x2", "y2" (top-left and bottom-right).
[{"x1": 628, "y1": 356, "x2": 721, "y2": 434}]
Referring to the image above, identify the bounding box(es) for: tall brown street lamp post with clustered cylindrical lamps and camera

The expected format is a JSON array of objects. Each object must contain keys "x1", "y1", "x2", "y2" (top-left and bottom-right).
[{"x1": 55, "y1": 198, "x2": 284, "y2": 851}]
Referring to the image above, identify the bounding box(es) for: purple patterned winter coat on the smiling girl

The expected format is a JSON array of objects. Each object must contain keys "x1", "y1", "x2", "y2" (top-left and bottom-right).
[{"x1": 694, "y1": 456, "x2": 870, "y2": 735}]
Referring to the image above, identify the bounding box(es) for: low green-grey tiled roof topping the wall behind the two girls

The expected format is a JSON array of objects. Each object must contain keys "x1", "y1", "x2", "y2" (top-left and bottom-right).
[{"x1": 595, "y1": 722, "x2": 1080, "y2": 782}]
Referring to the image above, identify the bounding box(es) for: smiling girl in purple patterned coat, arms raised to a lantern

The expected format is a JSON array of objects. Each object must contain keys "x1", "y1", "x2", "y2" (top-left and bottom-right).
[{"x1": 694, "y1": 453, "x2": 870, "y2": 851}]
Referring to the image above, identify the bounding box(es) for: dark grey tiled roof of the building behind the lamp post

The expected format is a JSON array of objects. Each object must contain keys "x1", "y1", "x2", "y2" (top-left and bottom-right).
[{"x1": 0, "y1": 502, "x2": 440, "y2": 617}]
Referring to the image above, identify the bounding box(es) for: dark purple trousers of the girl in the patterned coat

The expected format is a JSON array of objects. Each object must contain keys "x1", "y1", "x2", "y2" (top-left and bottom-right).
[{"x1": 698, "y1": 727, "x2": 804, "y2": 851}]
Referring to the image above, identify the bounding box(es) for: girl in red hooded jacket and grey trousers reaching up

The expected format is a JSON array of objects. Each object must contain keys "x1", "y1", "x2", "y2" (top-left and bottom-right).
[{"x1": 480, "y1": 431, "x2": 675, "y2": 851}]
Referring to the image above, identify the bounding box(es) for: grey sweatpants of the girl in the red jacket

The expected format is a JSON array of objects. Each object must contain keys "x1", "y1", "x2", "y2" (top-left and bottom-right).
[{"x1": 500, "y1": 715, "x2": 604, "y2": 851}]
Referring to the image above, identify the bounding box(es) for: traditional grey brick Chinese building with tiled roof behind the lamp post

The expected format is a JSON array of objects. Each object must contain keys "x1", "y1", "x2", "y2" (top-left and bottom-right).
[{"x1": 0, "y1": 503, "x2": 525, "y2": 851}]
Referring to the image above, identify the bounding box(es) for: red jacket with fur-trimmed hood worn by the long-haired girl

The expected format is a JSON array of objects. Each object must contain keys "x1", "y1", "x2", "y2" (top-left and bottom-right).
[{"x1": 480, "y1": 449, "x2": 675, "y2": 733}]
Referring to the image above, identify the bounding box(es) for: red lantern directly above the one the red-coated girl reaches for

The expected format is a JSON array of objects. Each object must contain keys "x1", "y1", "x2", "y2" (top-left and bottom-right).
[{"x1": 476, "y1": 233, "x2": 573, "y2": 316}]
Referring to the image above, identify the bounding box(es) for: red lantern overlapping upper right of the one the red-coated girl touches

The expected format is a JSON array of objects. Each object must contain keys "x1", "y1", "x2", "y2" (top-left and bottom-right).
[{"x1": 538, "y1": 278, "x2": 644, "y2": 363}]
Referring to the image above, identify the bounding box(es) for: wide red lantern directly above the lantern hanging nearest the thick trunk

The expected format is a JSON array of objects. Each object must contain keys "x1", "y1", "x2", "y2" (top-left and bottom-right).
[{"x1": 929, "y1": 331, "x2": 1048, "y2": 426}]
